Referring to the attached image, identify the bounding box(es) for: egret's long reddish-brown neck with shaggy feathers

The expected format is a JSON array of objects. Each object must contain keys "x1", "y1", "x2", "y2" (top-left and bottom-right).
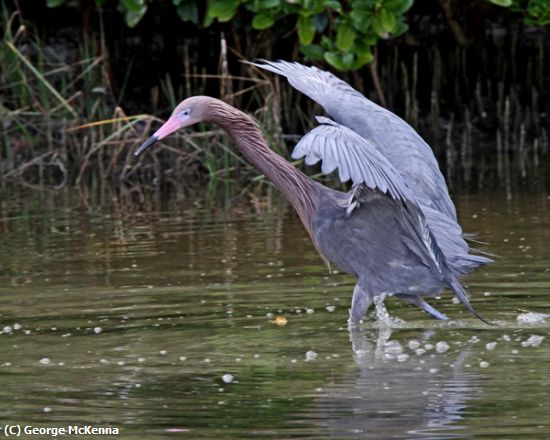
[{"x1": 210, "y1": 100, "x2": 319, "y2": 235}]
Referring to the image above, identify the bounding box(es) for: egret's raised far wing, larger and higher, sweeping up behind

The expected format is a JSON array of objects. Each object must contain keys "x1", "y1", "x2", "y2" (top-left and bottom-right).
[{"x1": 248, "y1": 60, "x2": 456, "y2": 220}]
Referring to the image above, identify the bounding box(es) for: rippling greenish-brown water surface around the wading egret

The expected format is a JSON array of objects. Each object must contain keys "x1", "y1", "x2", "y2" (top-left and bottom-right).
[{"x1": 0, "y1": 194, "x2": 550, "y2": 439}]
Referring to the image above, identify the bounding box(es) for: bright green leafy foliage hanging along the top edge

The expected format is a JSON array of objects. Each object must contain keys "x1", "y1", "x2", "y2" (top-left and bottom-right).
[{"x1": 46, "y1": 0, "x2": 413, "y2": 70}]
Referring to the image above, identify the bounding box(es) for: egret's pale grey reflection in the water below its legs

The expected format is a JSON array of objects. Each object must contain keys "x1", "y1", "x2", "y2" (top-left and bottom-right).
[{"x1": 317, "y1": 327, "x2": 479, "y2": 439}]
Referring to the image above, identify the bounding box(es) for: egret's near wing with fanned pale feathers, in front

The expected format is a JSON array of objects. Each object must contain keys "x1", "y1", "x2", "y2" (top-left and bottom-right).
[{"x1": 292, "y1": 117, "x2": 490, "y2": 319}]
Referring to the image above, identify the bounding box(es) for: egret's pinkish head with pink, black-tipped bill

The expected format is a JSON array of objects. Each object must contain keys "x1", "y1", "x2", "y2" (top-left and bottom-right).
[{"x1": 134, "y1": 96, "x2": 212, "y2": 156}]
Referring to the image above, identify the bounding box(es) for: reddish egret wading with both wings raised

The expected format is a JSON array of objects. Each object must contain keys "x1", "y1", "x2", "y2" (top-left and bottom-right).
[{"x1": 135, "y1": 61, "x2": 491, "y2": 323}]
